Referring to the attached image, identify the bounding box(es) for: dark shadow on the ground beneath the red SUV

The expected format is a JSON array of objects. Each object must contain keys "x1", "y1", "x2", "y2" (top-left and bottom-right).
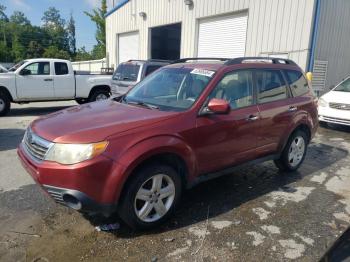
[{"x1": 81, "y1": 141, "x2": 348, "y2": 238}]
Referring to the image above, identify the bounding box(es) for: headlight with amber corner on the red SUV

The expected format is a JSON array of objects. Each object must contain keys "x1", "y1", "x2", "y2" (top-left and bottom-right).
[{"x1": 45, "y1": 141, "x2": 108, "y2": 165}]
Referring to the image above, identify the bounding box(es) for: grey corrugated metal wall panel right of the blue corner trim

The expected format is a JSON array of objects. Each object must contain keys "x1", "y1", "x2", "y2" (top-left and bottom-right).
[{"x1": 315, "y1": 0, "x2": 350, "y2": 90}]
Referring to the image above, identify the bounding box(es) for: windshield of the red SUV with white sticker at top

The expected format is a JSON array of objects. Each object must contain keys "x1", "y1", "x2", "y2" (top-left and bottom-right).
[{"x1": 123, "y1": 68, "x2": 215, "y2": 111}]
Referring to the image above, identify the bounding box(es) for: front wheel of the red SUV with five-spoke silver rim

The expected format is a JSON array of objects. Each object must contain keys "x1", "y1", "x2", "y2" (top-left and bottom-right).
[{"x1": 118, "y1": 164, "x2": 182, "y2": 230}]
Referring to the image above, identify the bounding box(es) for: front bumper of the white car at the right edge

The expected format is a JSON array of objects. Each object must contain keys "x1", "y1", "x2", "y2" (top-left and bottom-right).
[{"x1": 318, "y1": 107, "x2": 350, "y2": 126}]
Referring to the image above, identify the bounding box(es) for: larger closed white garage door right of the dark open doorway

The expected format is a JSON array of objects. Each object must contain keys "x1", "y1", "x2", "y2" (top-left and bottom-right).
[{"x1": 198, "y1": 14, "x2": 248, "y2": 58}]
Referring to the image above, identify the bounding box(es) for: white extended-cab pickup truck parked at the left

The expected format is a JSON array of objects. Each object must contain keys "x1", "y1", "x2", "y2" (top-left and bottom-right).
[{"x1": 0, "y1": 58, "x2": 112, "y2": 116}]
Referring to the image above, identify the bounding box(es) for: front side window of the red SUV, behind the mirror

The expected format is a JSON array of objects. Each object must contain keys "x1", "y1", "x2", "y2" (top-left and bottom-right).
[{"x1": 209, "y1": 70, "x2": 253, "y2": 109}]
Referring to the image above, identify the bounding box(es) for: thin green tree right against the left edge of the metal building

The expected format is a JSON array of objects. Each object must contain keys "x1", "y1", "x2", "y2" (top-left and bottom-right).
[{"x1": 84, "y1": 0, "x2": 107, "y2": 59}]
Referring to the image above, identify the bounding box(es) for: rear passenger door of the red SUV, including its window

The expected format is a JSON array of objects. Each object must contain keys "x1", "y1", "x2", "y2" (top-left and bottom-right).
[{"x1": 255, "y1": 69, "x2": 297, "y2": 156}]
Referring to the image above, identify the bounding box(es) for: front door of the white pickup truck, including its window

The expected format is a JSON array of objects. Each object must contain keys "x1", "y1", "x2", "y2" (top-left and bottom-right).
[{"x1": 16, "y1": 61, "x2": 54, "y2": 101}]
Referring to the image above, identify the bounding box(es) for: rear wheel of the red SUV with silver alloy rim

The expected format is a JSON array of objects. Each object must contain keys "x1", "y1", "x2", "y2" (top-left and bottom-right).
[{"x1": 274, "y1": 130, "x2": 309, "y2": 172}]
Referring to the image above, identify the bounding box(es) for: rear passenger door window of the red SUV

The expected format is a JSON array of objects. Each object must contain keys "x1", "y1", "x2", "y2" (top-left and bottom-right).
[{"x1": 256, "y1": 70, "x2": 288, "y2": 104}]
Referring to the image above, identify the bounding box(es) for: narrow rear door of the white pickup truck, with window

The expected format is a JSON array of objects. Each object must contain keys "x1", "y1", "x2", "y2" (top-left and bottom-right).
[{"x1": 54, "y1": 62, "x2": 75, "y2": 99}]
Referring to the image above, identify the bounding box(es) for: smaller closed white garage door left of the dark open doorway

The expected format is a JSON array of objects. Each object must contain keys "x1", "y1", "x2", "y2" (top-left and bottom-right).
[{"x1": 118, "y1": 32, "x2": 139, "y2": 63}]
